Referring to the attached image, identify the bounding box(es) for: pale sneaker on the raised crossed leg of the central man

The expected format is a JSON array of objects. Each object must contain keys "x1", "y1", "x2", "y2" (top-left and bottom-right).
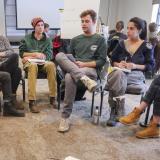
[{"x1": 80, "y1": 75, "x2": 97, "y2": 92}]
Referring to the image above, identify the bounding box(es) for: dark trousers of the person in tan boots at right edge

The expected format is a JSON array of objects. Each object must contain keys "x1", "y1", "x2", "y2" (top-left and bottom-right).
[{"x1": 142, "y1": 75, "x2": 160, "y2": 116}]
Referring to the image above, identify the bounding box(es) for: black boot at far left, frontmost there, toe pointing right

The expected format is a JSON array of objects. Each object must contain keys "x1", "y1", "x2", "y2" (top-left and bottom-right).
[{"x1": 3, "y1": 102, "x2": 25, "y2": 117}]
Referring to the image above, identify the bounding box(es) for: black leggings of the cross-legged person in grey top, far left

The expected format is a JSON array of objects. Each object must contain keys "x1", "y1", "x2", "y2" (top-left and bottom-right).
[{"x1": 0, "y1": 53, "x2": 22, "y2": 94}]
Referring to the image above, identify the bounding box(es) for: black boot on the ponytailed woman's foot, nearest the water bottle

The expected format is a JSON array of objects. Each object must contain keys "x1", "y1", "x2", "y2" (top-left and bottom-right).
[{"x1": 107, "y1": 106, "x2": 117, "y2": 127}]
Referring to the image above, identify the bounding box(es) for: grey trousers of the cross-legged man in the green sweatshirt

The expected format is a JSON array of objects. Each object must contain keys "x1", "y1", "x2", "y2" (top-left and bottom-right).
[{"x1": 56, "y1": 52, "x2": 97, "y2": 118}]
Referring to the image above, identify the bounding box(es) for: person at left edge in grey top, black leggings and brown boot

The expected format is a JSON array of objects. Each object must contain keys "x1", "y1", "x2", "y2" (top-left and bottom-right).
[{"x1": 0, "y1": 36, "x2": 24, "y2": 109}]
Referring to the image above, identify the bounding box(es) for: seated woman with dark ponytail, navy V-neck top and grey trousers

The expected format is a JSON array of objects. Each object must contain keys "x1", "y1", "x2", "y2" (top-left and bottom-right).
[{"x1": 107, "y1": 17, "x2": 154, "y2": 126}]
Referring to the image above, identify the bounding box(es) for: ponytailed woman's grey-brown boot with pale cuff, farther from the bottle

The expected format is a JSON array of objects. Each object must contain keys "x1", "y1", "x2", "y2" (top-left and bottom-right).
[{"x1": 116, "y1": 97, "x2": 125, "y2": 122}]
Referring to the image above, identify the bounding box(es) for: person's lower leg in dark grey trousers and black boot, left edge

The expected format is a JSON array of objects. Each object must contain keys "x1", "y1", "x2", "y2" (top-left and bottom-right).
[{"x1": 0, "y1": 71, "x2": 25, "y2": 117}]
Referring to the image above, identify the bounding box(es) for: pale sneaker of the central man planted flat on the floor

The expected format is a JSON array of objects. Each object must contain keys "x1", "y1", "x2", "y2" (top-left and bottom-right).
[{"x1": 58, "y1": 118, "x2": 69, "y2": 132}]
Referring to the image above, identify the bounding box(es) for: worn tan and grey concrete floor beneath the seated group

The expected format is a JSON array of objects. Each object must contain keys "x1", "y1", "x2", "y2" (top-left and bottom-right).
[{"x1": 0, "y1": 80, "x2": 160, "y2": 160}]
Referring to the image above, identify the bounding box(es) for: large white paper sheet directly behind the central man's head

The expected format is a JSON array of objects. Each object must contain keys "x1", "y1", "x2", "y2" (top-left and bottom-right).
[{"x1": 60, "y1": 0, "x2": 100, "y2": 39}]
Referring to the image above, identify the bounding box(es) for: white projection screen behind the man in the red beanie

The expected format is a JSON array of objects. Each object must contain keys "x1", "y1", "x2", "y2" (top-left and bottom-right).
[{"x1": 16, "y1": 0, "x2": 64, "y2": 29}]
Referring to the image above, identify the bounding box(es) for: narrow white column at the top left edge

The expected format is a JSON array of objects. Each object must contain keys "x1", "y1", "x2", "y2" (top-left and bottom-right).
[{"x1": 0, "y1": 0, "x2": 6, "y2": 36}]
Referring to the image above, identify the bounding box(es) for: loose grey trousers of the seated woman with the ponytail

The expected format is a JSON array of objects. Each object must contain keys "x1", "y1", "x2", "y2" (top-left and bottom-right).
[{"x1": 107, "y1": 70, "x2": 146, "y2": 107}]
